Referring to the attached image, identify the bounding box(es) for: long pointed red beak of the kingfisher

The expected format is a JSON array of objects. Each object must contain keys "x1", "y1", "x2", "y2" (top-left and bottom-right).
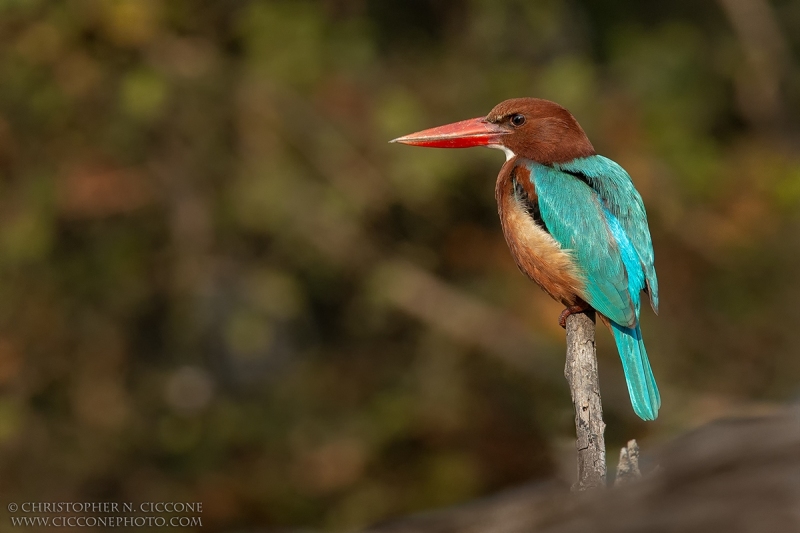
[{"x1": 389, "y1": 117, "x2": 511, "y2": 148}]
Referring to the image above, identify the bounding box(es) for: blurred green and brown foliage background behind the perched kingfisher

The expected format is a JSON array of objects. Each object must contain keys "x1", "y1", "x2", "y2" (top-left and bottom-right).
[{"x1": 0, "y1": 0, "x2": 800, "y2": 531}]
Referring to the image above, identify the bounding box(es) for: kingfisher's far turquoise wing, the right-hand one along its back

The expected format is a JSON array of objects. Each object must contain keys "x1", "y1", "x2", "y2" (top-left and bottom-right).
[{"x1": 553, "y1": 155, "x2": 658, "y2": 312}]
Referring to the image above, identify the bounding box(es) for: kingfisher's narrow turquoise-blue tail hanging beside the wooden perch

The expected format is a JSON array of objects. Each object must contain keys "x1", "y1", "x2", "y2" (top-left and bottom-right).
[{"x1": 611, "y1": 322, "x2": 661, "y2": 420}]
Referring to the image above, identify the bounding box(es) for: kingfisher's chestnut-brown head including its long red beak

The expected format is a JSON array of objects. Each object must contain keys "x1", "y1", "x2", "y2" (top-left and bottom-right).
[{"x1": 392, "y1": 98, "x2": 595, "y2": 164}]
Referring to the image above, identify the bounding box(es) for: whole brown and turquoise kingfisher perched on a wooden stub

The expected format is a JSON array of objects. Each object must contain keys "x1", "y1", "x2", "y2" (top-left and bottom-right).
[{"x1": 390, "y1": 98, "x2": 661, "y2": 420}]
